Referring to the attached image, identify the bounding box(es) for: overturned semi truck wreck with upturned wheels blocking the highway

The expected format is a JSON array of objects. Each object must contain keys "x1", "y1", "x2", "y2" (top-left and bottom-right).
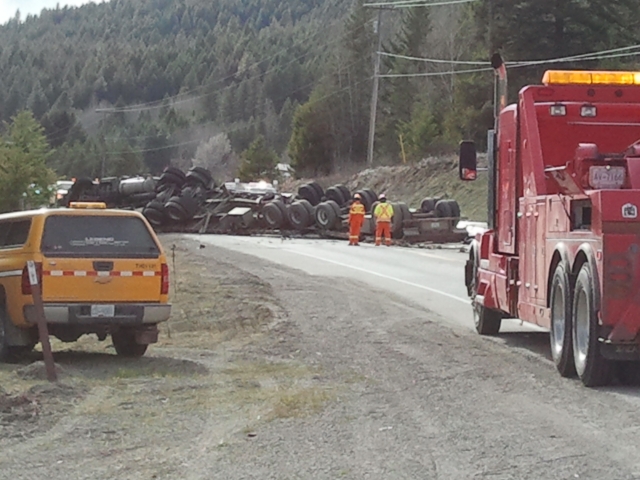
[{"x1": 61, "y1": 167, "x2": 467, "y2": 243}]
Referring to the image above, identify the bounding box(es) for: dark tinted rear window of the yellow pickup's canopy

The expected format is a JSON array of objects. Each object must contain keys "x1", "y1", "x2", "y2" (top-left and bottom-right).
[{"x1": 41, "y1": 215, "x2": 160, "y2": 258}]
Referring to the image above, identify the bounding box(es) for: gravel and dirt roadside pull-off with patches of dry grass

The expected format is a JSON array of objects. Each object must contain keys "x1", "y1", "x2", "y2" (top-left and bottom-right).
[{"x1": 0, "y1": 236, "x2": 640, "y2": 480}]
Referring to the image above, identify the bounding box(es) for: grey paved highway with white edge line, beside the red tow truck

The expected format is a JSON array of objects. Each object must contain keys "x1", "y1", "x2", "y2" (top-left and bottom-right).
[{"x1": 194, "y1": 235, "x2": 540, "y2": 333}]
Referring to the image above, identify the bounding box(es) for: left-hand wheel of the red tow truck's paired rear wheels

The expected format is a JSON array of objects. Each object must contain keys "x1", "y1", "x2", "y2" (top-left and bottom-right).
[{"x1": 549, "y1": 264, "x2": 576, "y2": 377}]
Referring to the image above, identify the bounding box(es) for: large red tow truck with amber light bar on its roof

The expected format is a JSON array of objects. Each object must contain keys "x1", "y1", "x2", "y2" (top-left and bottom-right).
[{"x1": 459, "y1": 56, "x2": 640, "y2": 387}]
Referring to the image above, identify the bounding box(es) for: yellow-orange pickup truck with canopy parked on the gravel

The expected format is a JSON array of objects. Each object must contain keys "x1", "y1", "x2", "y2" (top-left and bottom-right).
[{"x1": 0, "y1": 203, "x2": 171, "y2": 361}]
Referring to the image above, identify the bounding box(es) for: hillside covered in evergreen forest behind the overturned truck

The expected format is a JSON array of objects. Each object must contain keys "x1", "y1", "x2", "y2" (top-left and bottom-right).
[{"x1": 0, "y1": 0, "x2": 640, "y2": 184}]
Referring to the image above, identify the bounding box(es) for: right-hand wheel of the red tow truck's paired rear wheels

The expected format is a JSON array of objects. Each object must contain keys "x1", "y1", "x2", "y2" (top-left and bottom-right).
[{"x1": 572, "y1": 263, "x2": 613, "y2": 387}]
